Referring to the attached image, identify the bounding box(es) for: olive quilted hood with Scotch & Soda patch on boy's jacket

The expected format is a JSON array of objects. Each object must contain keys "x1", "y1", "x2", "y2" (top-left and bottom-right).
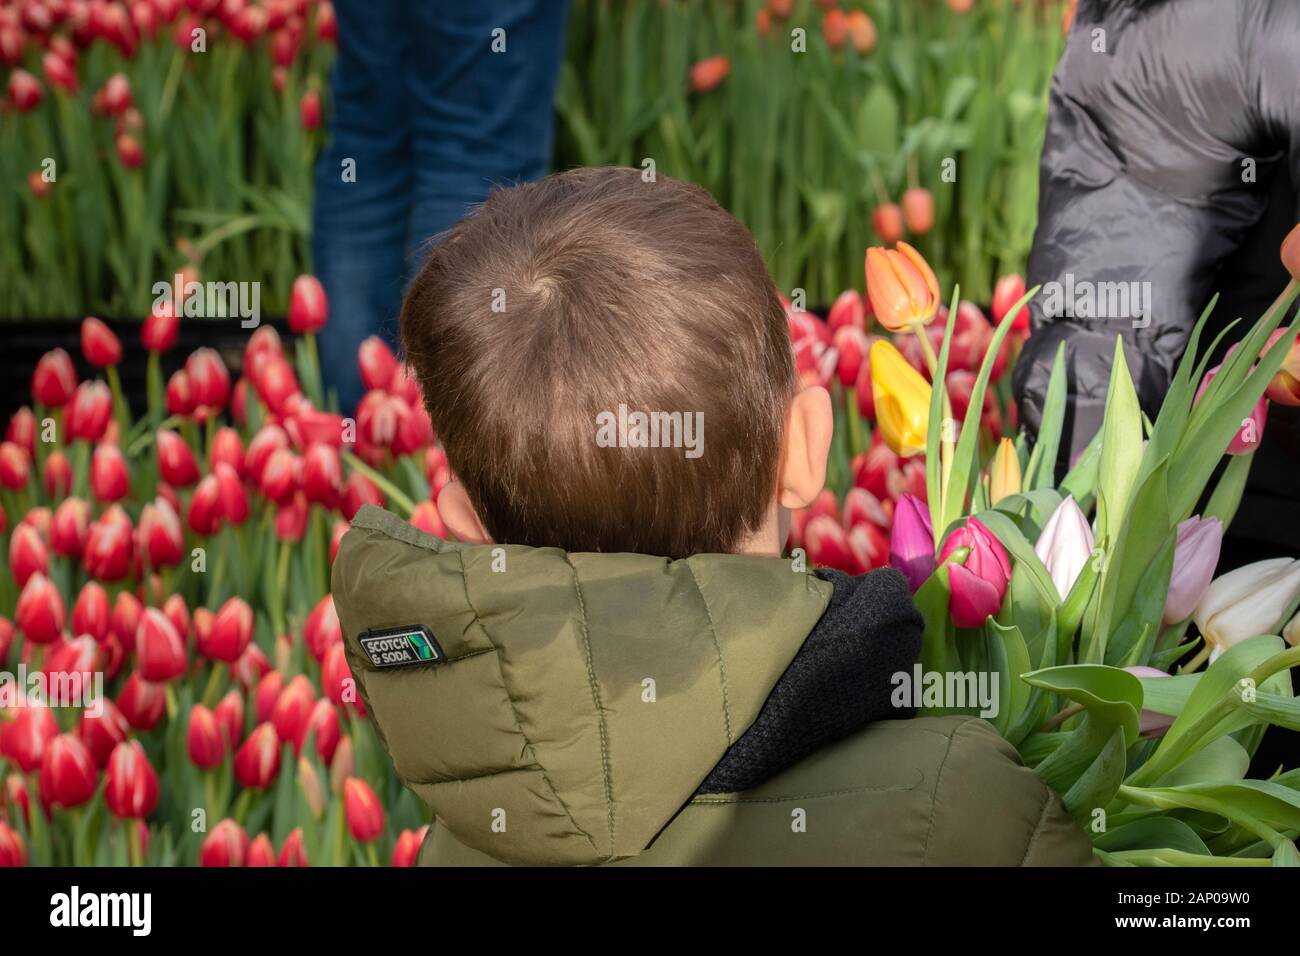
[{"x1": 333, "y1": 506, "x2": 832, "y2": 864}]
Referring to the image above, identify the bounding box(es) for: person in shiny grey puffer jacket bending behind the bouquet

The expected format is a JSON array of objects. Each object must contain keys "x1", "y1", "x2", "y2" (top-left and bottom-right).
[{"x1": 1014, "y1": 0, "x2": 1300, "y2": 554}]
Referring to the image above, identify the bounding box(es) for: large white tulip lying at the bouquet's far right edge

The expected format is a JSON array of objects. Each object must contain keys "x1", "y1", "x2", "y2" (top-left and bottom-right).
[{"x1": 1175, "y1": 561, "x2": 1300, "y2": 653}]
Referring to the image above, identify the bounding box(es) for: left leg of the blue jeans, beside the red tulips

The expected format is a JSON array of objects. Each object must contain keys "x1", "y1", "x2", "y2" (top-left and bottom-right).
[{"x1": 312, "y1": 0, "x2": 410, "y2": 415}]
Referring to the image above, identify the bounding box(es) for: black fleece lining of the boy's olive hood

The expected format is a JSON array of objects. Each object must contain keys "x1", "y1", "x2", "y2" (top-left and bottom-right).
[{"x1": 697, "y1": 568, "x2": 924, "y2": 793}]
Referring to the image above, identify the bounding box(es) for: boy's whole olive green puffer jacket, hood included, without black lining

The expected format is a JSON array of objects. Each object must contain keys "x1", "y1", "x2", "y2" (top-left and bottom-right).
[{"x1": 333, "y1": 507, "x2": 1092, "y2": 866}]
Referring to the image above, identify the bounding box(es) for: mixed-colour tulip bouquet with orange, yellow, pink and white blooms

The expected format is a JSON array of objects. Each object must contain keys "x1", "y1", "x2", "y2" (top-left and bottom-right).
[{"x1": 857, "y1": 228, "x2": 1300, "y2": 866}]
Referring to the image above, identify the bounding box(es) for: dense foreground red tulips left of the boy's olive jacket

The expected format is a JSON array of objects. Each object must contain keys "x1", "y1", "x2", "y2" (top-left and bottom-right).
[{"x1": 0, "y1": 276, "x2": 447, "y2": 866}]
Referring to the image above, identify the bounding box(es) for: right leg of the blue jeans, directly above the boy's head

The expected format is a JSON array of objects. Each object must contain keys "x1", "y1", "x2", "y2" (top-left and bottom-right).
[{"x1": 407, "y1": 0, "x2": 568, "y2": 268}]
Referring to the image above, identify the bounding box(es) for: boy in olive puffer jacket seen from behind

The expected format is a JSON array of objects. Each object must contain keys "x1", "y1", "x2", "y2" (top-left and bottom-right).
[{"x1": 333, "y1": 169, "x2": 1092, "y2": 865}]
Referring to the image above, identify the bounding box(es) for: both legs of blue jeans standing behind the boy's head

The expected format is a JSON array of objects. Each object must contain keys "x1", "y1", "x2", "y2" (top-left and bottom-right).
[{"x1": 312, "y1": 0, "x2": 567, "y2": 414}]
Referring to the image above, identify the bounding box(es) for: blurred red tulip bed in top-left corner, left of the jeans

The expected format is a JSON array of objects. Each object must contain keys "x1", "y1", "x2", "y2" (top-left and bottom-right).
[{"x1": 0, "y1": 0, "x2": 337, "y2": 317}]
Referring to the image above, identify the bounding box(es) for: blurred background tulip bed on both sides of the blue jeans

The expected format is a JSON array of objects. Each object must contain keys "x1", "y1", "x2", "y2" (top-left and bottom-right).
[{"x1": 0, "y1": 0, "x2": 1063, "y2": 319}]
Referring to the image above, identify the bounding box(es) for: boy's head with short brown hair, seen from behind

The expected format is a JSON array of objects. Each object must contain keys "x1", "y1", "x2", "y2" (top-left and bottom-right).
[{"x1": 402, "y1": 168, "x2": 831, "y2": 558}]
